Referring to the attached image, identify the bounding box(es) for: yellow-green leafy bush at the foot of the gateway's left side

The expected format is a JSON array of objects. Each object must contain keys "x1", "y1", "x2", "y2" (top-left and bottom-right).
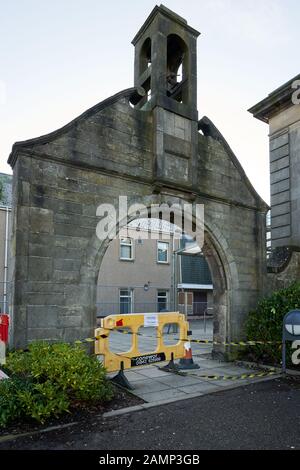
[{"x1": 0, "y1": 342, "x2": 113, "y2": 426}]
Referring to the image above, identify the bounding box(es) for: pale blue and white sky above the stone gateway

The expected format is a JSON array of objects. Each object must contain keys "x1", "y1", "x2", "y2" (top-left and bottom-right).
[{"x1": 0, "y1": 0, "x2": 300, "y2": 201}]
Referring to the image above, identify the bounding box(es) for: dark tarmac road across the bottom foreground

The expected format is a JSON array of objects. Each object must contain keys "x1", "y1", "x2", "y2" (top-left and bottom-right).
[{"x1": 0, "y1": 379, "x2": 300, "y2": 450}]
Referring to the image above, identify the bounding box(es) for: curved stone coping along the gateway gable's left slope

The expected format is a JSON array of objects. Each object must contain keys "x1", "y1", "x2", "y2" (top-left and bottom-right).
[{"x1": 7, "y1": 87, "x2": 145, "y2": 168}]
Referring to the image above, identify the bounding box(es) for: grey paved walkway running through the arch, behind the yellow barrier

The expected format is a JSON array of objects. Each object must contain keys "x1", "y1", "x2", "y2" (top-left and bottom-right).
[{"x1": 109, "y1": 320, "x2": 278, "y2": 404}]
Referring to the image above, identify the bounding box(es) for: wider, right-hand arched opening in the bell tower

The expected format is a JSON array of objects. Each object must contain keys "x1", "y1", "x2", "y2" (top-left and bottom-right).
[{"x1": 167, "y1": 34, "x2": 188, "y2": 103}]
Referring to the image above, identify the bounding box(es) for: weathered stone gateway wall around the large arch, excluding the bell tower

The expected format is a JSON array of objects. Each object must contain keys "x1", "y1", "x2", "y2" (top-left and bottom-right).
[{"x1": 9, "y1": 90, "x2": 267, "y2": 347}]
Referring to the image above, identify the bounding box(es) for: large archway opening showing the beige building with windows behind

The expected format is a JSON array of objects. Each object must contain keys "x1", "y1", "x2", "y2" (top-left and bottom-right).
[{"x1": 96, "y1": 213, "x2": 229, "y2": 354}]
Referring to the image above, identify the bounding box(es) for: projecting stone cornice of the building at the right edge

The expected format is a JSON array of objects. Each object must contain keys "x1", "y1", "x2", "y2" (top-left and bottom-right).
[{"x1": 248, "y1": 74, "x2": 300, "y2": 123}]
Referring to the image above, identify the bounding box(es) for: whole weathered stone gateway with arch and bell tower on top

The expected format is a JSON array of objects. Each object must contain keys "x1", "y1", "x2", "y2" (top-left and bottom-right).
[{"x1": 9, "y1": 6, "x2": 268, "y2": 347}]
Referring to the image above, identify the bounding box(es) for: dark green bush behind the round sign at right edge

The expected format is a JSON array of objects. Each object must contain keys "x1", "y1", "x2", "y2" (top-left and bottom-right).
[{"x1": 246, "y1": 283, "x2": 300, "y2": 365}]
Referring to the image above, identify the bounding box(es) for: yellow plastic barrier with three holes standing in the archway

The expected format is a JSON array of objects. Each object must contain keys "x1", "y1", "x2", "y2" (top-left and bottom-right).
[{"x1": 95, "y1": 312, "x2": 188, "y2": 372}]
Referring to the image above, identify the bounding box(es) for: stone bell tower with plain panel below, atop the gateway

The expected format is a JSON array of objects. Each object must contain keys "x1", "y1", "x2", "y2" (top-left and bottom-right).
[{"x1": 132, "y1": 5, "x2": 200, "y2": 187}]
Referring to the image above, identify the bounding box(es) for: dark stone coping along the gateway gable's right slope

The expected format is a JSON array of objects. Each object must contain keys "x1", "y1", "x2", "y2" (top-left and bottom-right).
[{"x1": 198, "y1": 116, "x2": 270, "y2": 211}]
